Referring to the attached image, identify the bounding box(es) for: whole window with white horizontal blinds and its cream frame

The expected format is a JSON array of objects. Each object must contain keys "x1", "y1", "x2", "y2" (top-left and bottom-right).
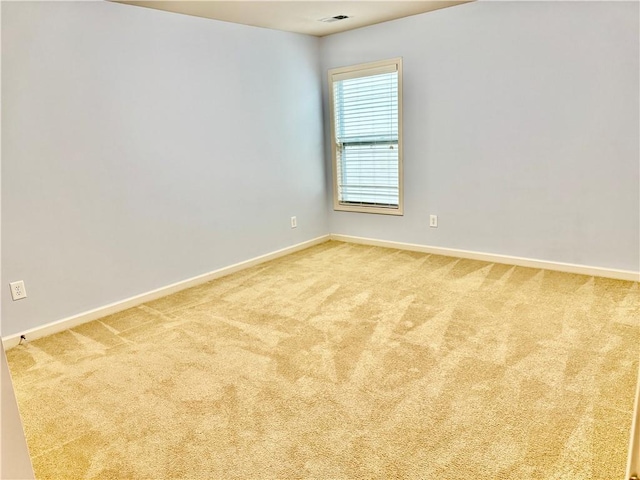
[{"x1": 329, "y1": 58, "x2": 402, "y2": 215}]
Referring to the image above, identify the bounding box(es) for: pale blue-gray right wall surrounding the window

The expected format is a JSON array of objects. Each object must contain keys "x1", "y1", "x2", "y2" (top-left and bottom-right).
[{"x1": 321, "y1": 2, "x2": 640, "y2": 271}]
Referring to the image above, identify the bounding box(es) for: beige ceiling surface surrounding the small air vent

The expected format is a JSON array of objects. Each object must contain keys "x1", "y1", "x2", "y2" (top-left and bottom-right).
[{"x1": 113, "y1": 0, "x2": 471, "y2": 37}]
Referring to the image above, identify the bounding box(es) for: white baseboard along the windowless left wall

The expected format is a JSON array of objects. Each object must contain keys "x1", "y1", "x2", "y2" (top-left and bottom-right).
[{"x1": 2, "y1": 235, "x2": 329, "y2": 350}]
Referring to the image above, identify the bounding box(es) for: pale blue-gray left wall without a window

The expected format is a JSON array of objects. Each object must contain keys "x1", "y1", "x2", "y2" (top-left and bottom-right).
[{"x1": 1, "y1": 2, "x2": 328, "y2": 336}]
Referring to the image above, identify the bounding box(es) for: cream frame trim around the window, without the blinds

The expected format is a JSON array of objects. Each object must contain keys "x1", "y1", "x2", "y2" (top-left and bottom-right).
[{"x1": 328, "y1": 57, "x2": 404, "y2": 215}]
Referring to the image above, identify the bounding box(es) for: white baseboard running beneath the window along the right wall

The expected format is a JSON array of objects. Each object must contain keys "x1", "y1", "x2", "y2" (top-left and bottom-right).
[{"x1": 330, "y1": 233, "x2": 640, "y2": 282}]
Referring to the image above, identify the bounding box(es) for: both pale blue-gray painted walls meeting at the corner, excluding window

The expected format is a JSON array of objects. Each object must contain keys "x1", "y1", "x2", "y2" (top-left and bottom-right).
[{"x1": 1, "y1": 2, "x2": 640, "y2": 336}]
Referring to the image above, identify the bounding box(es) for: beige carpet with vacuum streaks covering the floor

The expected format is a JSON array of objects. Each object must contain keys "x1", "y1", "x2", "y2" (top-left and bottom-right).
[{"x1": 8, "y1": 242, "x2": 640, "y2": 480}]
